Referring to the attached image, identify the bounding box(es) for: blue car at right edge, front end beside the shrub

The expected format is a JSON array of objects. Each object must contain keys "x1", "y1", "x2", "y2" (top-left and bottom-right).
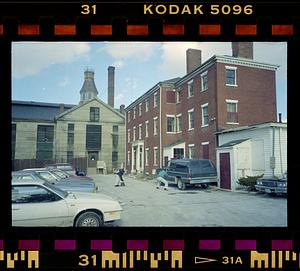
[{"x1": 255, "y1": 175, "x2": 287, "y2": 195}]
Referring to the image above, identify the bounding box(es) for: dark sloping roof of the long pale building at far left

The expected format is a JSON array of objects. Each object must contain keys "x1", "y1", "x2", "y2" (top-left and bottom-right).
[{"x1": 11, "y1": 101, "x2": 75, "y2": 121}]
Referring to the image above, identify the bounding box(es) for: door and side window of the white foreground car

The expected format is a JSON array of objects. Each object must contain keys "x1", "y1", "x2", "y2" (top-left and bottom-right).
[{"x1": 12, "y1": 185, "x2": 71, "y2": 227}]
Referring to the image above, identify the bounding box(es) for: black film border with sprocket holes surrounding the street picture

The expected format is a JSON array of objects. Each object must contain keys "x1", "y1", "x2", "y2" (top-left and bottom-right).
[{"x1": 0, "y1": 1, "x2": 300, "y2": 270}]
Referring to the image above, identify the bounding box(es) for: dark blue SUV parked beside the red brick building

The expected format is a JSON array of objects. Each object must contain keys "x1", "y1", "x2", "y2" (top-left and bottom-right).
[{"x1": 165, "y1": 159, "x2": 218, "y2": 190}]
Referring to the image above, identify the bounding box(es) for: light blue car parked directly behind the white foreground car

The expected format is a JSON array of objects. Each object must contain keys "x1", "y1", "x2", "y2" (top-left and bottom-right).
[{"x1": 12, "y1": 169, "x2": 98, "y2": 193}]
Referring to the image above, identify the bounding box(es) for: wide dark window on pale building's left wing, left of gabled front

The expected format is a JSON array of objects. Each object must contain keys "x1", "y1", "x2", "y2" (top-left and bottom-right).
[{"x1": 36, "y1": 125, "x2": 54, "y2": 160}]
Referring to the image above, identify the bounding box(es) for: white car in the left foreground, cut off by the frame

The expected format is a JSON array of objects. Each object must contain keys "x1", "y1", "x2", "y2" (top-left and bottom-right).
[{"x1": 12, "y1": 180, "x2": 122, "y2": 227}]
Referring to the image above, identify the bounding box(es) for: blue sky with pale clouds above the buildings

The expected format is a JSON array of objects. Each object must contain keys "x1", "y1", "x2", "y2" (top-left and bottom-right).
[{"x1": 12, "y1": 42, "x2": 287, "y2": 121}]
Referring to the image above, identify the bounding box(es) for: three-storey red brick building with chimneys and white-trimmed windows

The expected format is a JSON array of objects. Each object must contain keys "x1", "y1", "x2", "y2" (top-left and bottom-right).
[{"x1": 125, "y1": 42, "x2": 278, "y2": 174}]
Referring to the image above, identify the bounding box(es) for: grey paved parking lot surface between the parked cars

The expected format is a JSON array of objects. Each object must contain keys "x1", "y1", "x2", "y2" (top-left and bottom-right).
[{"x1": 90, "y1": 175, "x2": 287, "y2": 227}]
